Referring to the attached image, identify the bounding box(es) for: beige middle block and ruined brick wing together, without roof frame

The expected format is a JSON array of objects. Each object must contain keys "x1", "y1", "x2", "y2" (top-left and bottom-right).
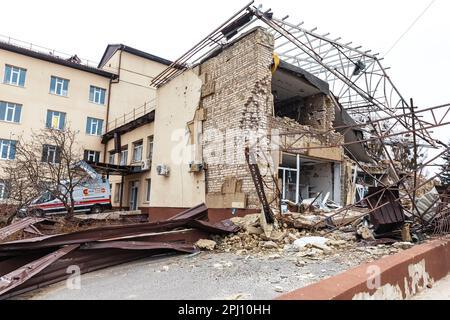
[{"x1": 0, "y1": 27, "x2": 362, "y2": 219}]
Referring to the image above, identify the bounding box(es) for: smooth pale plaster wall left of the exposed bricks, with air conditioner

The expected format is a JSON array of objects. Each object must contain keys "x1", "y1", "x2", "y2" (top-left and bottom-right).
[{"x1": 151, "y1": 71, "x2": 205, "y2": 208}]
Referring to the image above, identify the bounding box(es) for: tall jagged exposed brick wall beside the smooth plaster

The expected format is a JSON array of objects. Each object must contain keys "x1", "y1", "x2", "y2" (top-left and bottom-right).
[{"x1": 200, "y1": 28, "x2": 274, "y2": 209}]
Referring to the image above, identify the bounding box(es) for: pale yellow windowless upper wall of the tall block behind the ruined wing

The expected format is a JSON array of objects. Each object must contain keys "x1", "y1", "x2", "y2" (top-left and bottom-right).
[{"x1": 106, "y1": 51, "x2": 167, "y2": 128}]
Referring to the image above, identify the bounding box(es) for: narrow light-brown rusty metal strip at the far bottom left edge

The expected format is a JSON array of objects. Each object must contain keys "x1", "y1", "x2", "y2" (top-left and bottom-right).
[{"x1": 0, "y1": 245, "x2": 79, "y2": 296}]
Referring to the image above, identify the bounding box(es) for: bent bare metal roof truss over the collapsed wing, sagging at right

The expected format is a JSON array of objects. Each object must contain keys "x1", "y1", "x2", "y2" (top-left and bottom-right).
[{"x1": 152, "y1": 1, "x2": 450, "y2": 236}]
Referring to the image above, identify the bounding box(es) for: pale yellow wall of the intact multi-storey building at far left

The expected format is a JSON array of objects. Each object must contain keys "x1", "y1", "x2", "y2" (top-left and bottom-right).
[{"x1": 0, "y1": 50, "x2": 109, "y2": 172}]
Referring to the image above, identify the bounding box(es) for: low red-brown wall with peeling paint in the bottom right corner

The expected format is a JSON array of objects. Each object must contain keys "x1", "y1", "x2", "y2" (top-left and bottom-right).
[{"x1": 276, "y1": 240, "x2": 450, "y2": 300}]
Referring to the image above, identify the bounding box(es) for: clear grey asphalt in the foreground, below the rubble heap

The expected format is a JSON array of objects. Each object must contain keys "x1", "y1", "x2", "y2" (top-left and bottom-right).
[{"x1": 19, "y1": 253, "x2": 358, "y2": 300}]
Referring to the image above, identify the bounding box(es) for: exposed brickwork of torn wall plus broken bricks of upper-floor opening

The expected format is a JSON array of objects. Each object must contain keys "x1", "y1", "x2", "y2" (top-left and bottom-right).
[{"x1": 200, "y1": 28, "x2": 343, "y2": 209}]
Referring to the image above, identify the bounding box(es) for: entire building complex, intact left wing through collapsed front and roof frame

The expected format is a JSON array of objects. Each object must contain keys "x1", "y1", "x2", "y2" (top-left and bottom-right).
[{"x1": 0, "y1": 4, "x2": 446, "y2": 230}]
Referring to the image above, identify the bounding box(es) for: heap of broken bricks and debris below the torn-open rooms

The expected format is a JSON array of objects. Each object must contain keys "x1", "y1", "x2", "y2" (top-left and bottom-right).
[{"x1": 212, "y1": 212, "x2": 420, "y2": 267}]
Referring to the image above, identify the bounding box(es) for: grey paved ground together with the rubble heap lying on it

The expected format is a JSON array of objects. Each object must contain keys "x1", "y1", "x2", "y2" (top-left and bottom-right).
[{"x1": 12, "y1": 215, "x2": 422, "y2": 300}]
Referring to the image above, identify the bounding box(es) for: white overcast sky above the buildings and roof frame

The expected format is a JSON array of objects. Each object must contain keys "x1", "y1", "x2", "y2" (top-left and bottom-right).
[{"x1": 0, "y1": 0, "x2": 450, "y2": 168}]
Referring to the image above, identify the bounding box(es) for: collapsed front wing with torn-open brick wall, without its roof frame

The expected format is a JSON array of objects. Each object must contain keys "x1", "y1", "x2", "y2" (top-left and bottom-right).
[{"x1": 98, "y1": 27, "x2": 362, "y2": 219}]
